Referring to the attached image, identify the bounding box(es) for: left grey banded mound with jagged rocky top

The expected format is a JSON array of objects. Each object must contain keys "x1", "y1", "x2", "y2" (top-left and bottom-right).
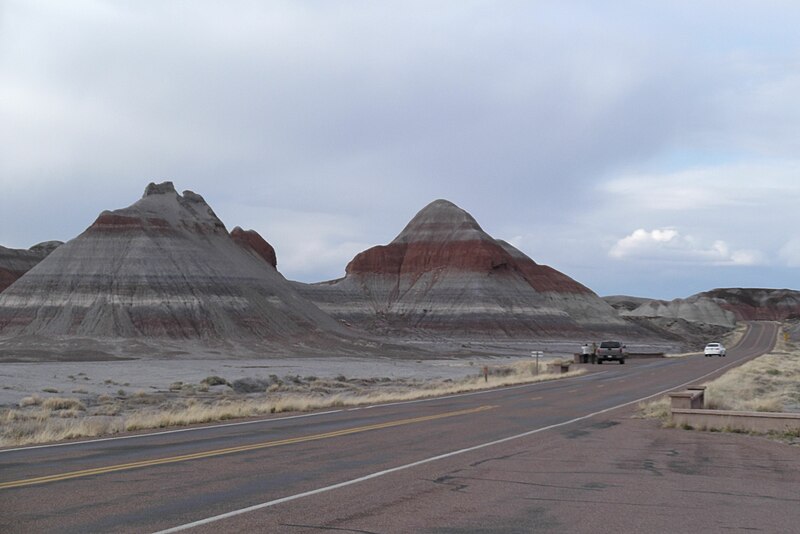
[{"x1": 0, "y1": 182, "x2": 344, "y2": 341}]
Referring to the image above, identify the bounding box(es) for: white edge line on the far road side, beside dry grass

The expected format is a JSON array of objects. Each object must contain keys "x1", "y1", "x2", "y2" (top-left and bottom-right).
[{"x1": 0, "y1": 371, "x2": 608, "y2": 454}]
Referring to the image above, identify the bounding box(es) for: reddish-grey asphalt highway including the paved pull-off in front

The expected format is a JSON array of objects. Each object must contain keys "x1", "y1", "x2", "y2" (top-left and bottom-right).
[{"x1": 0, "y1": 323, "x2": 800, "y2": 533}]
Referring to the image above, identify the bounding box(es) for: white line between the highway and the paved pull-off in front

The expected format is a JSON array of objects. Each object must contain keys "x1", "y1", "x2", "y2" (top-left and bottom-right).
[{"x1": 154, "y1": 350, "x2": 756, "y2": 534}]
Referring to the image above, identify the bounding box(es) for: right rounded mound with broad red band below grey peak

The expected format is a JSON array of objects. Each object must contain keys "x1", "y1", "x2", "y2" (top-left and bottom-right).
[{"x1": 296, "y1": 200, "x2": 634, "y2": 339}]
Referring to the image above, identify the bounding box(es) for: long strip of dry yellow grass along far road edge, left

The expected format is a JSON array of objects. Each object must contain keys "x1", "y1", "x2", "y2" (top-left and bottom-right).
[{"x1": 0, "y1": 361, "x2": 585, "y2": 446}]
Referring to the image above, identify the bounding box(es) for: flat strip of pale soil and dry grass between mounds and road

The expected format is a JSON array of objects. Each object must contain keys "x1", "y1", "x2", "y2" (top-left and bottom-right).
[{"x1": 0, "y1": 358, "x2": 585, "y2": 446}]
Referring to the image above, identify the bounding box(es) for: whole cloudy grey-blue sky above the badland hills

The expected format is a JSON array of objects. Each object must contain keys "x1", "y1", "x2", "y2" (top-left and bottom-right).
[{"x1": 0, "y1": 0, "x2": 800, "y2": 298}]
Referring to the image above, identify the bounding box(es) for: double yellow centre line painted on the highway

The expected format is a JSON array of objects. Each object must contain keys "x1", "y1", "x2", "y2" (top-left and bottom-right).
[{"x1": 0, "y1": 406, "x2": 498, "y2": 490}]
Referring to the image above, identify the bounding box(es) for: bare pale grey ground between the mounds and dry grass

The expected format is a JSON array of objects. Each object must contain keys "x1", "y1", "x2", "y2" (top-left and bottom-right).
[{"x1": 0, "y1": 338, "x2": 674, "y2": 407}]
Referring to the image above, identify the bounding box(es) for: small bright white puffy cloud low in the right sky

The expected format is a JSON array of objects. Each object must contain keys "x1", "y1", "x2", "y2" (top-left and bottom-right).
[{"x1": 608, "y1": 228, "x2": 765, "y2": 265}]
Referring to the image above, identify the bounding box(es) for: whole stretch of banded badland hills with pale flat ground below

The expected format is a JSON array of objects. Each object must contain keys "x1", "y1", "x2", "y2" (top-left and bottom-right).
[{"x1": 0, "y1": 182, "x2": 800, "y2": 446}]
